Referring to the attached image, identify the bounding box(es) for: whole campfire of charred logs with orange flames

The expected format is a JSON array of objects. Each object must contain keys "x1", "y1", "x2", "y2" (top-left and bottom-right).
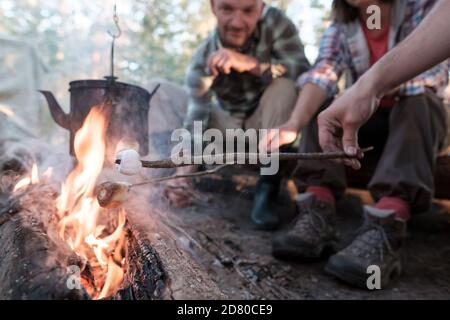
[{"x1": 0, "y1": 90, "x2": 224, "y2": 299}]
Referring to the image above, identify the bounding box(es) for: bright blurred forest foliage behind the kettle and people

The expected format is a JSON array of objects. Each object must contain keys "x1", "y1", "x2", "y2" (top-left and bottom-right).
[{"x1": 0, "y1": 0, "x2": 327, "y2": 89}]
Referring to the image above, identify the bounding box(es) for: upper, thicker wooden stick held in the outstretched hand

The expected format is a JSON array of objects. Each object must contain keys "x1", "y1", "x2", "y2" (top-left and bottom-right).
[{"x1": 115, "y1": 147, "x2": 373, "y2": 169}]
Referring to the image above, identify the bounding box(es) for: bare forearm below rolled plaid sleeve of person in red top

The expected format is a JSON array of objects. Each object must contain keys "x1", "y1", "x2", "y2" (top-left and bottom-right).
[{"x1": 289, "y1": 83, "x2": 327, "y2": 131}]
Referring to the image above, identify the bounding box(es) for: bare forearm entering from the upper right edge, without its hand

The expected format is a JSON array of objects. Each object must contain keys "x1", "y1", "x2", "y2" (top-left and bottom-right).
[{"x1": 366, "y1": 1, "x2": 450, "y2": 97}]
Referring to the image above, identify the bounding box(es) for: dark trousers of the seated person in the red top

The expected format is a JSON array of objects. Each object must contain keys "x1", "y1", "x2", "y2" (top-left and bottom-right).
[{"x1": 296, "y1": 92, "x2": 448, "y2": 213}]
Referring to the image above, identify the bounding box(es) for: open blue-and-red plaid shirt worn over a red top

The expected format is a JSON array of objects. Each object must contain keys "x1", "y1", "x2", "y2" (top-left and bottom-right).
[{"x1": 299, "y1": 0, "x2": 449, "y2": 97}]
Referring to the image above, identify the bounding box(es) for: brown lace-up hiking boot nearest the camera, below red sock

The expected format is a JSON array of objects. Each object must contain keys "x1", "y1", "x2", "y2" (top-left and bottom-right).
[{"x1": 325, "y1": 206, "x2": 406, "y2": 289}]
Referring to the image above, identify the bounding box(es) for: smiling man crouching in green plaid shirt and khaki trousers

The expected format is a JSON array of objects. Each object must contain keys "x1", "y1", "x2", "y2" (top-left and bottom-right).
[{"x1": 167, "y1": 0, "x2": 309, "y2": 229}]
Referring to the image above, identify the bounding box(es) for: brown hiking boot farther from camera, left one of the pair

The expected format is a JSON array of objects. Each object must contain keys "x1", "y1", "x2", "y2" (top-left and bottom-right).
[{"x1": 272, "y1": 193, "x2": 338, "y2": 260}]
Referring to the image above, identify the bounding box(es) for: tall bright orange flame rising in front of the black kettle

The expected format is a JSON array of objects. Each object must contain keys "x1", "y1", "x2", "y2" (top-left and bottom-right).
[{"x1": 57, "y1": 106, "x2": 125, "y2": 299}]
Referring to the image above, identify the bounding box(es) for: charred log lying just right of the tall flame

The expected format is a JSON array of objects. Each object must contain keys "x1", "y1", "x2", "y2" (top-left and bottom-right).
[{"x1": 119, "y1": 192, "x2": 226, "y2": 300}]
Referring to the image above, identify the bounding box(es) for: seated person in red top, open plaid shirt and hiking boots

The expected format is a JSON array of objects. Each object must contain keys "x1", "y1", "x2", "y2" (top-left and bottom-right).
[{"x1": 262, "y1": 0, "x2": 448, "y2": 287}]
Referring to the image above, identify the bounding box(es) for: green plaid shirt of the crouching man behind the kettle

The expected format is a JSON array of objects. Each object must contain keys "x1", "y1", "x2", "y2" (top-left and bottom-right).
[{"x1": 184, "y1": 5, "x2": 310, "y2": 129}]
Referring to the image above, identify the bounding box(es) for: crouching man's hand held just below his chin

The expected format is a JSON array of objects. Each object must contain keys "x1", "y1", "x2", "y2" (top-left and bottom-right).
[{"x1": 208, "y1": 48, "x2": 259, "y2": 76}]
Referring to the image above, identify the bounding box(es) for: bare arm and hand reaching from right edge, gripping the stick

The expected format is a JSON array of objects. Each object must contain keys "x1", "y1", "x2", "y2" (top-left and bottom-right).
[{"x1": 318, "y1": 1, "x2": 450, "y2": 169}]
